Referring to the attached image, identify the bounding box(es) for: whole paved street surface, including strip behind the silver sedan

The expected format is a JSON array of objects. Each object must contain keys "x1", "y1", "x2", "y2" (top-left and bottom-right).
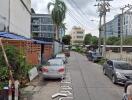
[{"x1": 30, "y1": 52, "x2": 123, "y2": 100}]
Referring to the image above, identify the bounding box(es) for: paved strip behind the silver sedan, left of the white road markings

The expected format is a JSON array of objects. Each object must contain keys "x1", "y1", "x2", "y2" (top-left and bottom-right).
[{"x1": 21, "y1": 74, "x2": 60, "y2": 100}]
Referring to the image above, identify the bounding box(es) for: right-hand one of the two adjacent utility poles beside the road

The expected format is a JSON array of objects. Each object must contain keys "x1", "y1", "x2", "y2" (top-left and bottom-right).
[{"x1": 96, "y1": 0, "x2": 112, "y2": 58}]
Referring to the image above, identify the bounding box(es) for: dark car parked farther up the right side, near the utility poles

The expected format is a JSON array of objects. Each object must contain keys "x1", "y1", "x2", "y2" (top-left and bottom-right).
[{"x1": 86, "y1": 51, "x2": 102, "y2": 62}]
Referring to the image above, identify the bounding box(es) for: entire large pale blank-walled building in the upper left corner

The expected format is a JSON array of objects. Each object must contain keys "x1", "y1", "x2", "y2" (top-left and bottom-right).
[{"x1": 0, "y1": 0, "x2": 31, "y2": 37}]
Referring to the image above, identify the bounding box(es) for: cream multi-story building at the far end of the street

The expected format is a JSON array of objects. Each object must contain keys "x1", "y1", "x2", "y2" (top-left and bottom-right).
[{"x1": 70, "y1": 26, "x2": 85, "y2": 45}]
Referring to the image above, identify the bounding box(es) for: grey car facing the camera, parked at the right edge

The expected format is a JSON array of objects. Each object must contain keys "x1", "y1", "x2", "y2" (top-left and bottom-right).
[{"x1": 103, "y1": 60, "x2": 132, "y2": 84}]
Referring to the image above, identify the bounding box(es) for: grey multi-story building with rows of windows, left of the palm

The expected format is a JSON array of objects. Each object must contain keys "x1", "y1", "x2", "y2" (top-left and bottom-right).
[{"x1": 31, "y1": 13, "x2": 55, "y2": 39}]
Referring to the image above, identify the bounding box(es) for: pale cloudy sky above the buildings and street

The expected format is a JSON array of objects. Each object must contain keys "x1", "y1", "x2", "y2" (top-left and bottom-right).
[{"x1": 31, "y1": 0, "x2": 132, "y2": 36}]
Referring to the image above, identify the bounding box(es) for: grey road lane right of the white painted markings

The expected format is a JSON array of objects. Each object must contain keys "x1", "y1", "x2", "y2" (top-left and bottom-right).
[{"x1": 67, "y1": 52, "x2": 123, "y2": 100}]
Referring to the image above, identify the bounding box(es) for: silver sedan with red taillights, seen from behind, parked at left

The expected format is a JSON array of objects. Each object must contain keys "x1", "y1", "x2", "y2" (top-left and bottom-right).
[{"x1": 42, "y1": 59, "x2": 66, "y2": 79}]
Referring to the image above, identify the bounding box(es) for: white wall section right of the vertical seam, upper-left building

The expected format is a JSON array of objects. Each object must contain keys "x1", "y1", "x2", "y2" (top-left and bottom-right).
[{"x1": 10, "y1": 0, "x2": 31, "y2": 37}]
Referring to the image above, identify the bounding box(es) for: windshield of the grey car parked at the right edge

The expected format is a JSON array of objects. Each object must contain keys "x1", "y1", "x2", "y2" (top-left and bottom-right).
[{"x1": 115, "y1": 63, "x2": 132, "y2": 70}]
